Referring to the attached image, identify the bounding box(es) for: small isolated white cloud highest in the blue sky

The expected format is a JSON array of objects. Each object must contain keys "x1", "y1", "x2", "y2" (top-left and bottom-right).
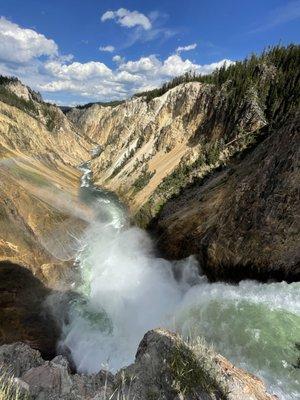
[{"x1": 101, "y1": 8, "x2": 152, "y2": 30}]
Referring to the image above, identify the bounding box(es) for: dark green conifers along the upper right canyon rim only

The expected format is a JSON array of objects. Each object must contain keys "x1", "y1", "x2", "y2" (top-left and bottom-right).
[{"x1": 136, "y1": 44, "x2": 300, "y2": 141}]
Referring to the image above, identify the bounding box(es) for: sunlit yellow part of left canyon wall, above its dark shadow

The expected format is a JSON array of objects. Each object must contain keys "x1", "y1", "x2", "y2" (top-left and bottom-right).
[{"x1": 0, "y1": 78, "x2": 92, "y2": 284}]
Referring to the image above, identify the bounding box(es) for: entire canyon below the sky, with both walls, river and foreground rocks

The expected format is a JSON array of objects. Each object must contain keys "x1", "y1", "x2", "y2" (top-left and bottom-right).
[{"x1": 0, "y1": 46, "x2": 300, "y2": 400}]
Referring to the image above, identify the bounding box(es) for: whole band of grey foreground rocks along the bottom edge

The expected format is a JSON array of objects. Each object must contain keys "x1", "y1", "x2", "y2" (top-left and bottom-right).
[{"x1": 0, "y1": 329, "x2": 276, "y2": 400}]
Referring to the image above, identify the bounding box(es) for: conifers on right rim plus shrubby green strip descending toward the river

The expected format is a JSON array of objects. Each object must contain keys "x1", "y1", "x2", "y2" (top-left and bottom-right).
[{"x1": 136, "y1": 45, "x2": 300, "y2": 226}]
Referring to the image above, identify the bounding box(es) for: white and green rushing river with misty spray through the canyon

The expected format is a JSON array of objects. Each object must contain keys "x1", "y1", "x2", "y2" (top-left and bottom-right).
[{"x1": 59, "y1": 164, "x2": 300, "y2": 399}]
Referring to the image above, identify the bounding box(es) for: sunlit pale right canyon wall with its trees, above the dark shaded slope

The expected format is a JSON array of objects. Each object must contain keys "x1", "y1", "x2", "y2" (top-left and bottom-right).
[{"x1": 67, "y1": 45, "x2": 300, "y2": 231}]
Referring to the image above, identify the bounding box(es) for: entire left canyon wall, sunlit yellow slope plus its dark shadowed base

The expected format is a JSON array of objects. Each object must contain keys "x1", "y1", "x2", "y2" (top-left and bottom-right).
[{"x1": 0, "y1": 78, "x2": 93, "y2": 358}]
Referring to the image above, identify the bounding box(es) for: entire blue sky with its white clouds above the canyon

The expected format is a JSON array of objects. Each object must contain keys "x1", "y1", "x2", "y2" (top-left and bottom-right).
[{"x1": 0, "y1": 0, "x2": 300, "y2": 104}]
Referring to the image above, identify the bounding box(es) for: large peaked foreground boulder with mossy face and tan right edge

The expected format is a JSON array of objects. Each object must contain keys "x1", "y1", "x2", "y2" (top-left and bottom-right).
[{"x1": 116, "y1": 329, "x2": 276, "y2": 400}]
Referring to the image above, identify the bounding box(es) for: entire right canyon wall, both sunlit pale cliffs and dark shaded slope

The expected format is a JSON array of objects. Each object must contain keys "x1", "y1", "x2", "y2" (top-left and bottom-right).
[{"x1": 68, "y1": 45, "x2": 300, "y2": 280}]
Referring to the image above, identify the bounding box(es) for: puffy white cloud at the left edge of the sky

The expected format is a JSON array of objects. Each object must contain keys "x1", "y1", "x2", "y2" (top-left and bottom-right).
[{"x1": 0, "y1": 17, "x2": 58, "y2": 63}]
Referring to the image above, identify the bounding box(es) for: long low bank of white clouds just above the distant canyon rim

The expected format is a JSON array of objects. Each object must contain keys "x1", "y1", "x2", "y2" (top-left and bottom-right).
[{"x1": 39, "y1": 54, "x2": 232, "y2": 101}]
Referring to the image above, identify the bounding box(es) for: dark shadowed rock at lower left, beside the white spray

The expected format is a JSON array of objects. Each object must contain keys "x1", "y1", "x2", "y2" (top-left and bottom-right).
[{"x1": 0, "y1": 262, "x2": 60, "y2": 359}]
